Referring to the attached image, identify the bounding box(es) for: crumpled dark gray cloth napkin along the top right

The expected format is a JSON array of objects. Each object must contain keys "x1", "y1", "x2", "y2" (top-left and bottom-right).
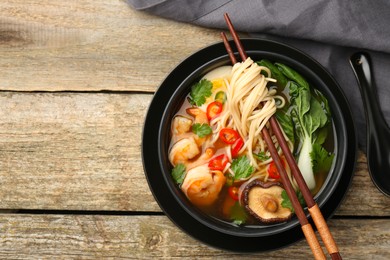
[{"x1": 127, "y1": 0, "x2": 390, "y2": 151}]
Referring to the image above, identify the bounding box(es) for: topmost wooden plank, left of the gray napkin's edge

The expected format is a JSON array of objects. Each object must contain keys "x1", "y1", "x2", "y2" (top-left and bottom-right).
[{"x1": 0, "y1": 0, "x2": 220, "y2": 92}]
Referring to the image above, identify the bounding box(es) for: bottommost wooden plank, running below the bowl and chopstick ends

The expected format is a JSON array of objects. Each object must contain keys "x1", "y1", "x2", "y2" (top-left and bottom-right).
[{"x1": 0, "y1": 215, "x2": 390, "y2": 260}]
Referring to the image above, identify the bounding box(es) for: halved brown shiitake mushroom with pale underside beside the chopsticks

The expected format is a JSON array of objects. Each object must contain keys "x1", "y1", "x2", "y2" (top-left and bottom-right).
[{"x1": 243, "y1": 180, "x2": 293, "y2": 224}]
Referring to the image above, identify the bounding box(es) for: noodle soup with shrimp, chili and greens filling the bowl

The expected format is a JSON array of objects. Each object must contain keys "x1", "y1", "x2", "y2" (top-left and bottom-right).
[{"x1": 168, "y1": 58, "x2": 334, "y2": 225}]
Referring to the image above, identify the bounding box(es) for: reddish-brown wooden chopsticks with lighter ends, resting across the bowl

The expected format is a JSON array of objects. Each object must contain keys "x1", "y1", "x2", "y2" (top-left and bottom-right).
[{"x1": 221, "y1": 14, "x2": 342, "y2": 259}]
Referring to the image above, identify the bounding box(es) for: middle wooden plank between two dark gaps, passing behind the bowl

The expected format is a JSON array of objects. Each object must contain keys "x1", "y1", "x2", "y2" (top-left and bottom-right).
[{"x1": 0, "y1": 92, "x2": 390, "y2": 216}]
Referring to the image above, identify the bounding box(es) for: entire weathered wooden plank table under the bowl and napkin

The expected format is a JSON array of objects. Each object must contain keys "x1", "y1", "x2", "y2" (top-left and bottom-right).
[{"x1": 0, "y1": 0, "x2": 390, "y2": 259}]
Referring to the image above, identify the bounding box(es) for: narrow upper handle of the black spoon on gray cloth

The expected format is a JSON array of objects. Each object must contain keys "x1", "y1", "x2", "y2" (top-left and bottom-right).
[{"x1": 350, "y1": 52, "x2": 387, "y2": 130}]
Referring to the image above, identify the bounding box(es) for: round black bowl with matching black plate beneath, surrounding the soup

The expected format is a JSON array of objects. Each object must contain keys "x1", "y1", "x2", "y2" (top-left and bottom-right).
[{"x1": 142, "y1": 39, "x2": 357, "y2": 252}]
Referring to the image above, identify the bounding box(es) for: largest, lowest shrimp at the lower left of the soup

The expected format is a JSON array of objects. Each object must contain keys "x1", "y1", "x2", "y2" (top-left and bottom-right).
[{"x1": 181, "y1": 164, "x2": 226, "y2": 206}]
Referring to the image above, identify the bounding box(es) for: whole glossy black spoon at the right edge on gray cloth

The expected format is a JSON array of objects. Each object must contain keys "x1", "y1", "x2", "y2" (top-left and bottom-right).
[{"x1": 350, "y1": 52, "x2": 390, "y2": 196}]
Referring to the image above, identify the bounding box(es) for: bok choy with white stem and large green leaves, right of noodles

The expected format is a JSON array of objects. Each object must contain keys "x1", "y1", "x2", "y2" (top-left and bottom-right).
[{"x1": 257, "y1": 60, "x2": 334, "y2": 189}]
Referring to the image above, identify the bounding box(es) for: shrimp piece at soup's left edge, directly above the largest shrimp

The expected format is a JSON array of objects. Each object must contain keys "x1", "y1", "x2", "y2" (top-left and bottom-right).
[{"x1": 169, "y1": 136, "x2": 200, "y2": 166}]
